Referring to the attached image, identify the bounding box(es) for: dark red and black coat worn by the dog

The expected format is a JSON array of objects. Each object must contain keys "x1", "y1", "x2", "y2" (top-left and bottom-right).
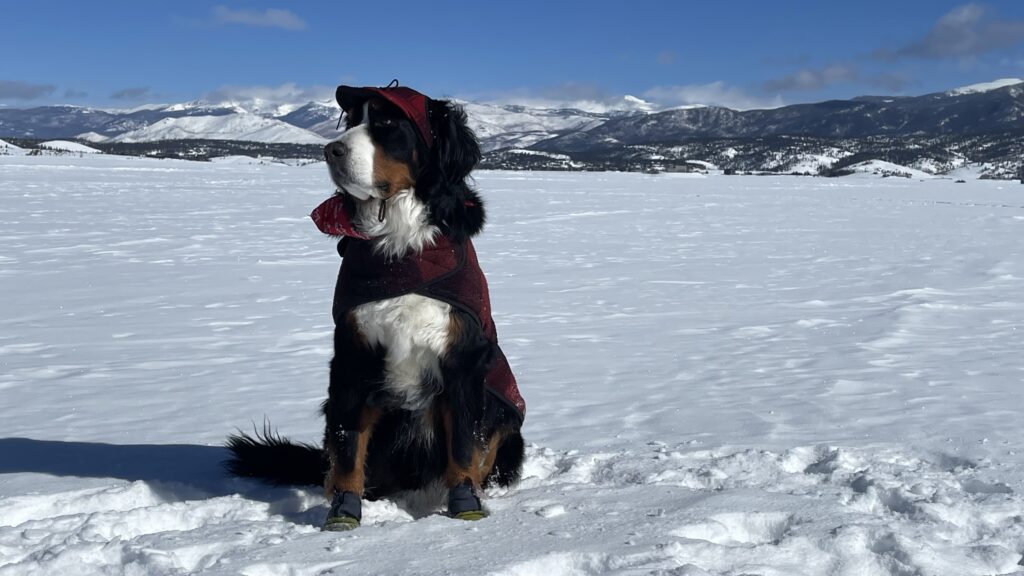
[{"x1": 311, "y1": 197, "x2": 526, "y2": 420}]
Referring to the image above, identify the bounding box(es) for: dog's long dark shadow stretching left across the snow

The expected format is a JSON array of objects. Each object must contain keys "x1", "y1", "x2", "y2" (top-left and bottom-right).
[{"x1": 0, "y1": 438, "x2": 326, "y2": 526}]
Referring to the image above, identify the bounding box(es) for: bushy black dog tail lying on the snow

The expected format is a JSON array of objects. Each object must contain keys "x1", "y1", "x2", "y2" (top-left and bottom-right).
[{"x1": 224, "y1": 425, "x2": 327, "y2": 486}]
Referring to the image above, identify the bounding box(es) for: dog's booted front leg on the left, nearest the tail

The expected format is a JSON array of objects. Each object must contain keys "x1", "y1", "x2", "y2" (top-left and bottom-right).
[{"x1": 324, "y1": 319, "x2": 383, "y2": 531}]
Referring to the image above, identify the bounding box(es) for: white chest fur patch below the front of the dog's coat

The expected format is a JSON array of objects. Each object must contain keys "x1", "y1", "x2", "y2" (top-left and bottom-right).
[{"x1": 352, "y1": 294, "x2": 452, "y2": 410}]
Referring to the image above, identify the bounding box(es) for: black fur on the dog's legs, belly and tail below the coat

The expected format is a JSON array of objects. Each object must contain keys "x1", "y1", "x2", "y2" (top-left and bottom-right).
[{"x1": 227, "y1": 312, "x2": 524, "y2": 499}]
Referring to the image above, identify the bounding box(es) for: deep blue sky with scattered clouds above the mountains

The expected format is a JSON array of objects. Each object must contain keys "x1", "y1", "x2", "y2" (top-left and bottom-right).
[{"x1": 6, "y1": 0, "x2": 1024, "y2": 110}]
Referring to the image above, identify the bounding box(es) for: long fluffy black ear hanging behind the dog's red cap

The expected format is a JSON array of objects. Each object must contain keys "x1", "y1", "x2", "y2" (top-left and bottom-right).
[{"x1": 417, "y1": 100, "x2": 485, "y2": 242}]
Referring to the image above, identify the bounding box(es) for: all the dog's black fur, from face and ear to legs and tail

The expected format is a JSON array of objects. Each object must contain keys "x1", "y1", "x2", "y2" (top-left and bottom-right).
[{"x1": 227, "y1": 96, "x2": 524, "y2": 499}]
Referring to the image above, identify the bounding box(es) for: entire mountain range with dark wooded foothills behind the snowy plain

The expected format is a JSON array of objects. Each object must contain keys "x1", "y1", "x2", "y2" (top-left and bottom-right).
[{"x1": 0, "y1": 79, "x2": 1024, "y2": 173}]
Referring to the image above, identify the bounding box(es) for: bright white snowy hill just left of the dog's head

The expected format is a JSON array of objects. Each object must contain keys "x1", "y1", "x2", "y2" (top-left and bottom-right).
[{"x1": 111, "y1": 113, "x2": 328, "y2": 143}]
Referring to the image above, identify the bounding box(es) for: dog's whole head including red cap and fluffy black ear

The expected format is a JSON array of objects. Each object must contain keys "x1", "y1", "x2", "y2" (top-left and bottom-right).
[{"x1": 324, "y1": 82, "x2": 484, "y2": 249}]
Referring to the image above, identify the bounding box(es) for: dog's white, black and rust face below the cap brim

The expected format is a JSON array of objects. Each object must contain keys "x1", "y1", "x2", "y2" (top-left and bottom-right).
[{"x1": 324, "y1": 98, "x2": 426, "y2": 200}]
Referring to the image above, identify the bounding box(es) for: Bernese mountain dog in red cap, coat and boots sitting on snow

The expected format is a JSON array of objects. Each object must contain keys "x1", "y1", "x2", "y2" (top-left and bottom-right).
[{"x1": 227, "y1": 83, "x2": 525, "y2": 531}]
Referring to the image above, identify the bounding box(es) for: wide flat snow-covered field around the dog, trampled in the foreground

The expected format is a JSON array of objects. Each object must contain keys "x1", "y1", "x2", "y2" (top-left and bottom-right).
[{"x1": 0, "y1": 155, "x2": 1024, "y2": 576}]
